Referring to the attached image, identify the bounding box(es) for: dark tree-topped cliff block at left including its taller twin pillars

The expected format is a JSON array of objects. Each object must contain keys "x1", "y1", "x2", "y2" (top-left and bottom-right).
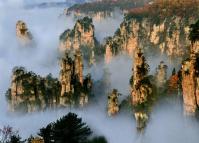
[{"x1": 6, "y1": 51, "x2": 92, "y2": 112}]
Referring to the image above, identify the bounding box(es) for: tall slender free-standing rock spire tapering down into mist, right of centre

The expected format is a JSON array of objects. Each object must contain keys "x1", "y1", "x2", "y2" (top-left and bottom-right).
[{"x1": 131, "y1": 49, "x2": 152, "y2": 131}]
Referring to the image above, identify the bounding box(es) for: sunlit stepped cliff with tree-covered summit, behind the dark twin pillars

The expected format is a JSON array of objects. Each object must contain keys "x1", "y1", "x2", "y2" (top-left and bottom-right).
[{"x1": 59, "y1": 17, "x2": 96, "y2": 52}]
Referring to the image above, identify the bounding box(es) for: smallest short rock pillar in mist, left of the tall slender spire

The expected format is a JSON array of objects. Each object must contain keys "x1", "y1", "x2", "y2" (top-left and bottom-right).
[{"x1": 108, "y1": 89, "x2": 119, "y2": 116}]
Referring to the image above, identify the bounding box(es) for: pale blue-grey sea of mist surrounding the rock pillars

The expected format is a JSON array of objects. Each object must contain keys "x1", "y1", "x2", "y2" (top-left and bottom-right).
[{"x1": 0, "y1": 0, "x2": 199, "y2": 143}]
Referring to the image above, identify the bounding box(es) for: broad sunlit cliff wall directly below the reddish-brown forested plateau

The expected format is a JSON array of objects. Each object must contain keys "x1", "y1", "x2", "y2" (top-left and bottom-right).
[{"x1": 105, "y1": 16, "x2": 192, "y2": 62}]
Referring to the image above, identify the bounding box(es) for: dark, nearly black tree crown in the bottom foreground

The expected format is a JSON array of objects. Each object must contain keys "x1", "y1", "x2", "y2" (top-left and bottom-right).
[{"x1": 39, "y1": 113, "x2": 92, "y2": 143}]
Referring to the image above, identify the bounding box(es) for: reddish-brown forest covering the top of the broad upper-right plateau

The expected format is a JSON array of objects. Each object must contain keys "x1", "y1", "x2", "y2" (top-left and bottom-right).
[{"x1": 125, "y1": 0, "x2": 199, "y2": 23}]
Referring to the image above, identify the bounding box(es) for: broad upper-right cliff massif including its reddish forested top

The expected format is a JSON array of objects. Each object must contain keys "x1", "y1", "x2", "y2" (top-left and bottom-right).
[{"x1": 105, "y1": 2, "x2": 198, "y2": 62}]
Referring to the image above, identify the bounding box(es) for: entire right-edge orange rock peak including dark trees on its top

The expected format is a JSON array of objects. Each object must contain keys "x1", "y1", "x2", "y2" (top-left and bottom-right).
[{"x1": 181, "y1": 20, "x2": 199, "y2": 115}]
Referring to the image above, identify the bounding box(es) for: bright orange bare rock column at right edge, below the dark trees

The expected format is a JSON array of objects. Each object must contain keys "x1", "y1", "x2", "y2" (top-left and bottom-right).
[{"x1": 181, "y1": 53, "x2": 199, "y2": 115}]
